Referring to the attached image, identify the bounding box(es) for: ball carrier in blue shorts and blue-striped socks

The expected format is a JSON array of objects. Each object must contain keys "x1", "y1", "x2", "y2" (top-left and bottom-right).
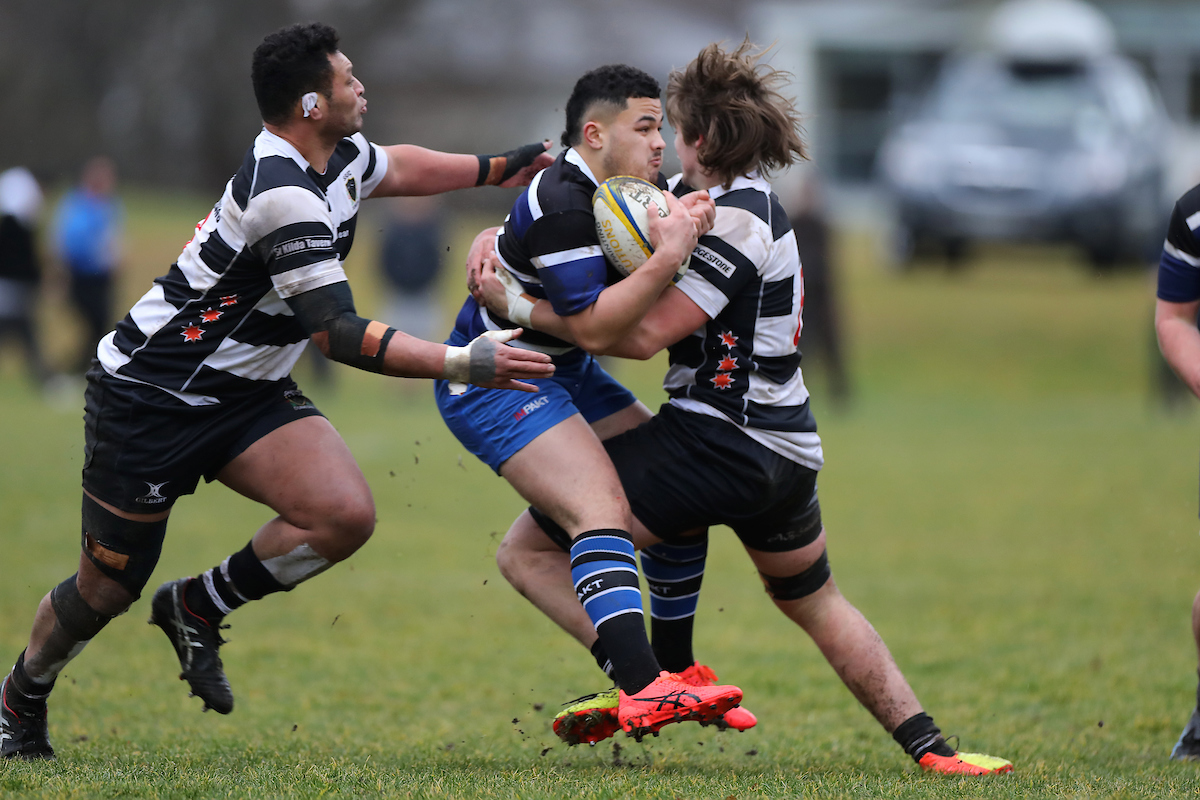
[{"x1": 436, "y1": 65, "x2": 742, "y2": 736}]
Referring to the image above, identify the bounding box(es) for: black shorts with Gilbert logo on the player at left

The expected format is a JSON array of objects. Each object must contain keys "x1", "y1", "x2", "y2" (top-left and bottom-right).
[{"x1": 83, "y1": 366, "x2": 323, "y2": 513}]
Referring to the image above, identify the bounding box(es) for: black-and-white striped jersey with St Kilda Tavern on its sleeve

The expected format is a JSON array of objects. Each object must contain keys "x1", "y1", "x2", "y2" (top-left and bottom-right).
[{"x1": 97, "y1": 130, "x2": 388, "y2": 405}]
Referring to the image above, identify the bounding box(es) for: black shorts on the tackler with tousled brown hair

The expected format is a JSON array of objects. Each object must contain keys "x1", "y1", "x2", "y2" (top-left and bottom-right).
[{"x1": 604, "y1": 404, "x2": 821, "y2": 553}]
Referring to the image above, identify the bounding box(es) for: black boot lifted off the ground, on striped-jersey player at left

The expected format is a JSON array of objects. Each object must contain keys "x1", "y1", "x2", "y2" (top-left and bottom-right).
[{"x1": 150, "y1": 578, "x2": 233, "y2": 714}]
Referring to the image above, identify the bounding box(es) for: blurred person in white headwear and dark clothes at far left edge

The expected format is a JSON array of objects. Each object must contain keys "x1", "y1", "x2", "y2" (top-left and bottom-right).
[{"x1": 0, "y1": 167, "x2": 48, "y2": 386}]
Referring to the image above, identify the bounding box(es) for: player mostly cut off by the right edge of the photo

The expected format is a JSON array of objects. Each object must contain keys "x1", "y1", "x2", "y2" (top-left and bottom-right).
[{"x1": 1154, "y1": 186, "x2": 1200, "y2": 760}]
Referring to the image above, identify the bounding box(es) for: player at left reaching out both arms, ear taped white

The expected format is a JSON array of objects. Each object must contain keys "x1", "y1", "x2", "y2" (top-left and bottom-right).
[{"x1": 0, "y1": 24, "x2": 554, "y2": 759}]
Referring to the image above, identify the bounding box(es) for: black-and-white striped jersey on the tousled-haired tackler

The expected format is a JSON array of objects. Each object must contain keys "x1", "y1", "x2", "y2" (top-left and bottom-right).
[{"x1": 662, "y1": 174, "x2": 824, "y2": 469}]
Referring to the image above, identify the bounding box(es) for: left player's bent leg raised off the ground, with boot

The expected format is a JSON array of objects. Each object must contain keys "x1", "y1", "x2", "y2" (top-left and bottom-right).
[{"x1": 150, "y1": 415, "x2": 374, "y2": 714}]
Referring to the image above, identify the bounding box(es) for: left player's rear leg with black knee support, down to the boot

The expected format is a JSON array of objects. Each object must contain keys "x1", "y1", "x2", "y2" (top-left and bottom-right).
[{"x1": 0, "y1": 493, "x2": 170, "y2": 759}]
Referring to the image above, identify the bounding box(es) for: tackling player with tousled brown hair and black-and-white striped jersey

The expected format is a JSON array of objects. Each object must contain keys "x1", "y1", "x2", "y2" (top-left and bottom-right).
[{"x1": 482, "y1": 42, "x2": 1012, "y2": 775}]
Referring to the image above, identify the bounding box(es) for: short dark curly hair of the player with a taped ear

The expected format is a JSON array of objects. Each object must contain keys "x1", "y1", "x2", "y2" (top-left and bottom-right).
[{"x1": 250, "y1": 23, "x2": 338, "y2": 125}]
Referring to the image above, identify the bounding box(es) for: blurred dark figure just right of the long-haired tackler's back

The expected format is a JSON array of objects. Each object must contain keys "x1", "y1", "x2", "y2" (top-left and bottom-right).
[{"x1": 787, "y1": 172, "x2": 850, "y2": 408}]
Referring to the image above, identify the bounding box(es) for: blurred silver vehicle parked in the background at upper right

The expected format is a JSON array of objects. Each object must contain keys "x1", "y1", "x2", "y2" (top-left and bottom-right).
[{"x1": 878, "y1": 1, "x2": 1169, "y2": 270}]
